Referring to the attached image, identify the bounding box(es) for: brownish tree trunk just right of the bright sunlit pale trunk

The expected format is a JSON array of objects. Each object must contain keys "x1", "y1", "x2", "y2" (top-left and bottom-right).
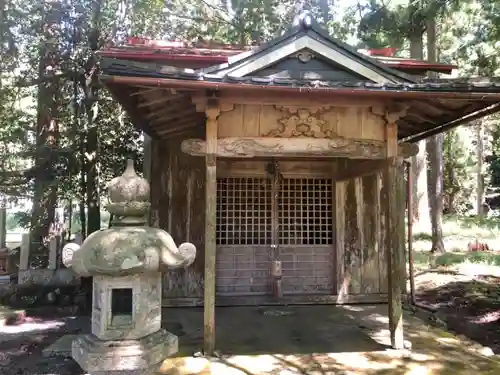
[{"x1": 426, "y1": 19, "x2": 444, "y2": 253}]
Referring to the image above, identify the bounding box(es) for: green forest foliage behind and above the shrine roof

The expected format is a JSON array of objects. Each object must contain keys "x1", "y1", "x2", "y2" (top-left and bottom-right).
[{"x1": 0, "y1": 0, "x2": 500, "y2": 244}]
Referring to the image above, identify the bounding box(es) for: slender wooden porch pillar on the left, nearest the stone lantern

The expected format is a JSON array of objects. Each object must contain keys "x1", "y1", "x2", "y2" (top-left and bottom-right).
[{"x1": 203, "y1": 105, "x2": 220, "y2": 355}]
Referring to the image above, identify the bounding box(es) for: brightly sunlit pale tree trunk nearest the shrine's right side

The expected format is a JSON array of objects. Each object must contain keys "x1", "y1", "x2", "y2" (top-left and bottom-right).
[{"x1": 410, "y1": 32, "x2": 431, "y2": 232}]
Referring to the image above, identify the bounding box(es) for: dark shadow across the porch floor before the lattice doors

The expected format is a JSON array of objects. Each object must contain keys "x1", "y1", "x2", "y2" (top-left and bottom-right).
[{"x1": 164, "y1": 306, "x2": 386, "y2": 355}]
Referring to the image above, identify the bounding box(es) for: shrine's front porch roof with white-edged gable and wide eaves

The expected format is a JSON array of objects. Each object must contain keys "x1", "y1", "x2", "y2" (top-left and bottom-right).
[{"x1": 100, "y1": 13, "x2": 500, "y2": 142}]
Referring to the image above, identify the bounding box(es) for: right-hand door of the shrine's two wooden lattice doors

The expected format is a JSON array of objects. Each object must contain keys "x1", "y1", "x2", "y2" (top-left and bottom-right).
[{"x1": 278, "y1": 178, "x2": 334, "y2": 294}]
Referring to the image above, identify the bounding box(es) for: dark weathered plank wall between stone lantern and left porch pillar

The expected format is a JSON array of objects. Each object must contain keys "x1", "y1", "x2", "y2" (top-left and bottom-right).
[{"x1": 159, "y1": 130, "x2": 205, "y2": 298}]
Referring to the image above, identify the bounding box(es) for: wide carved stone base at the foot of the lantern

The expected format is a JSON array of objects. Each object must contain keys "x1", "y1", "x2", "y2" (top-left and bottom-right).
[{"x1": 71, "y1": 329, "x2": 179, "y2": 375}]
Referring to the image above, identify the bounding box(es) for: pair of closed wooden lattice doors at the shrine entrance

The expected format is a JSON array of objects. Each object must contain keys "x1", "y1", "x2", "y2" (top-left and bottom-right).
[{"x1": 216, "y1": 174, "x2": 334, "y2": 296}]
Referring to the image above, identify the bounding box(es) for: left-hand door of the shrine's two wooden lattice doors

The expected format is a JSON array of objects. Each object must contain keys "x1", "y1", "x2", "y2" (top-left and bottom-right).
[{"x1": 216, "y1": 178, "x2": 272, "y2": 296}]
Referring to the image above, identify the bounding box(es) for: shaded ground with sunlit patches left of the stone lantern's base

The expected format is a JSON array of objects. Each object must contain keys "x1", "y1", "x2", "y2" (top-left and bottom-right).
[{"x1": 0, "y1": 317, "x2": 89, "y2": 375}]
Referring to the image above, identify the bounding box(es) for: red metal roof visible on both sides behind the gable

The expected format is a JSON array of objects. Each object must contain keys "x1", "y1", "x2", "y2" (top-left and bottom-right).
[{"x1": 99, "y1": 37, "x2": 458, "y2": 74}]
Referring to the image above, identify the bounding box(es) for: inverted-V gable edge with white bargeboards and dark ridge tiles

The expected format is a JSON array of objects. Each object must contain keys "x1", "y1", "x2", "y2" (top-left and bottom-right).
[{"x1": 201, "y1": 18, "x2": 415, "y2": 84}]
